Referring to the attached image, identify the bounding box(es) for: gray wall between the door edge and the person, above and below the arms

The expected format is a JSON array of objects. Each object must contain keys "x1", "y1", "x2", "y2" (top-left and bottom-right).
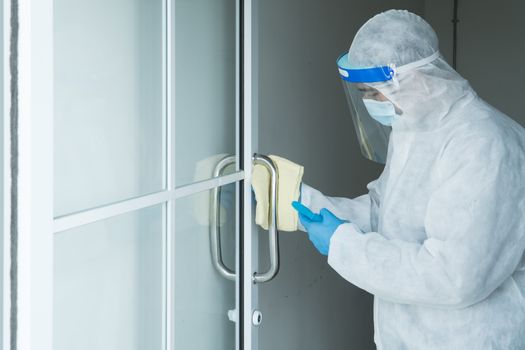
[{"x1": 257, "y1": 0, "x2": 424, "y2": 350}]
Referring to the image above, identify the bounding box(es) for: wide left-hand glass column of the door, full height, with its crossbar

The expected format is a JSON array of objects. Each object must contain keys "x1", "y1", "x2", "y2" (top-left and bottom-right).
[{"x1": 53, "y1": 0, "x2": 169, "y2": 350}]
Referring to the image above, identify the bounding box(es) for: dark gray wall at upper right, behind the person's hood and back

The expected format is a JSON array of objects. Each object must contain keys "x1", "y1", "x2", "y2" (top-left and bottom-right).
[{"x1": 425, "y1": 0, "x2": 525, "y2": 126}]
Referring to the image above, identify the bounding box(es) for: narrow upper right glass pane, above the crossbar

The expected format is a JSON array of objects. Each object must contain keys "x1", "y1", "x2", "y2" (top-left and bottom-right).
[{"x1": 174, "y1": 0, "x2": 236, "y2": 186}]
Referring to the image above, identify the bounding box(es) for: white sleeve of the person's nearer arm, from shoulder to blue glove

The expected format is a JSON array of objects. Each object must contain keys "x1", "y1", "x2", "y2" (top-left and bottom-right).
[{"x1": 328, "y1": 135, "x2": 525, "y2": 308}]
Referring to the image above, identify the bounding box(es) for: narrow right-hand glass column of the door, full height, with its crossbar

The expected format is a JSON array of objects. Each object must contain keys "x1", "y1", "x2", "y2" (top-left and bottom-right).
[{"x1": 171, "y1": 0, "x2": 239, "y2": 350}]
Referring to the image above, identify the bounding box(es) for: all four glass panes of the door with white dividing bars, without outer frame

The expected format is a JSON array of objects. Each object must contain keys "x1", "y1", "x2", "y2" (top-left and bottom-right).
[{"x1": 53, "y1": 0, "x2": 243, "y2": 350}]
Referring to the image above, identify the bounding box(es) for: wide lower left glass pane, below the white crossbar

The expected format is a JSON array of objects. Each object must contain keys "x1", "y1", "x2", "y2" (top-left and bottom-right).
[{"x1": 53, "y1": 206, "x2": 164, "y2": 350}]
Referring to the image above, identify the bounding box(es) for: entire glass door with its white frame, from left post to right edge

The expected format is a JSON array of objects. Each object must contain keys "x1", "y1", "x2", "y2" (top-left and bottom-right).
[{"x1": 13, "y1": 0, "x2": 260, "y2": 350}]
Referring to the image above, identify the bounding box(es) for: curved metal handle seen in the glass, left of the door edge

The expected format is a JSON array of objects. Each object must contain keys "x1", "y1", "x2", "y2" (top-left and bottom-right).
[{"x1": 210, "y1": 156, "x2": 235, "y2": 281}]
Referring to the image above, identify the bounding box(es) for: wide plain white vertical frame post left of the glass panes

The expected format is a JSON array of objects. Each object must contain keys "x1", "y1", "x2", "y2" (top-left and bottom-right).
[{"x1": 16, "y1": 0, "x2": 53, "y2": 350}]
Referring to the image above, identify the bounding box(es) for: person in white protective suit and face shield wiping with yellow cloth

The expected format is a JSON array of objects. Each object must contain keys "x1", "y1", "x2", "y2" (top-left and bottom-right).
[{"x1": 253, "y1": 10, "x2": 525, "y2": 350}]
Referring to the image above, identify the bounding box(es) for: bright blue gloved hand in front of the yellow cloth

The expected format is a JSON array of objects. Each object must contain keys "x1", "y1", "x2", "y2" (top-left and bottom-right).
[{"x1": 299, "y1": 208, "x2": 348, "y2": 255}]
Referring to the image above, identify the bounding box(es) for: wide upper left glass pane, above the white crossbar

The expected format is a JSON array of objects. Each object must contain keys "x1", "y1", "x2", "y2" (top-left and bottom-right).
[{"x1": 54, "y1": 0, "x2": 163, "y2": 216}]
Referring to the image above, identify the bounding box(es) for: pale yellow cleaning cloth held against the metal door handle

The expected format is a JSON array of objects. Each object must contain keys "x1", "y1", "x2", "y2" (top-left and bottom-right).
[{"x1": 252, "y1": 156, "x2": 304, "y2": 231}]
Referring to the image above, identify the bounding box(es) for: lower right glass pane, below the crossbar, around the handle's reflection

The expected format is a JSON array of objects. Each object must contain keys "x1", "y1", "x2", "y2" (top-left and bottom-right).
[{"x1": 174, "y1": 184, "x2": 236, "y2": 350}]
